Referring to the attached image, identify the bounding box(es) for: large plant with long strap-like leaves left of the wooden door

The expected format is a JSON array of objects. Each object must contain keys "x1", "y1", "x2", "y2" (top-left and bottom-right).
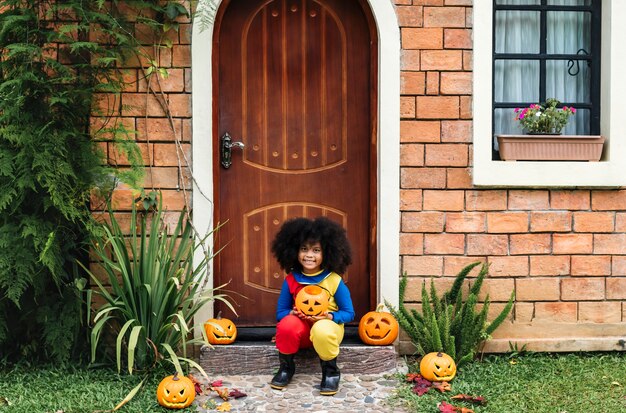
[{"x1": 83, "y1": 196, "x2": 235, "y2": 375}]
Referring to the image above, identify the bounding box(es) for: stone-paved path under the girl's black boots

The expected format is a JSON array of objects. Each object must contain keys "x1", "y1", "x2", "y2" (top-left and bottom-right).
[{"x1": 194, "y1": 358, "x2": 407, "y2": 413}]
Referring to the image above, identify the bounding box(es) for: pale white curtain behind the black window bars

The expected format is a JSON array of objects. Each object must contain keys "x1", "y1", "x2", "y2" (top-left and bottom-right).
[{"x1": 493, "y1": 0, "x2": 591, "y2": 150}]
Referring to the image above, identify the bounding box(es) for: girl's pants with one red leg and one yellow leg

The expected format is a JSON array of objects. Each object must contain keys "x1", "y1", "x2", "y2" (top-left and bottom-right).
[{"x1": 276, "y1": 315, "x2": 344, "y2": 360}]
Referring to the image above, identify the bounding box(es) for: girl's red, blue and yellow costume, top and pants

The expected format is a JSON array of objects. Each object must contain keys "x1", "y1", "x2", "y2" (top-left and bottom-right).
[{"x1": 276, "y1": 270, "x2": 354, "y2": 361}]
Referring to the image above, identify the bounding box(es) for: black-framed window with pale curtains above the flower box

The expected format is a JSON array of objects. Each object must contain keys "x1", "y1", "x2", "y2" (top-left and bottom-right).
[{"x1": 492, "y1": 0, "x2": 601, "y2": 160}]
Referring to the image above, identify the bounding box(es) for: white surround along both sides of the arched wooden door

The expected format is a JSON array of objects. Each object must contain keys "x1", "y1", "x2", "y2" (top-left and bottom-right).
[{"x1": 191, "y1": 0, "x2": 400, "y2": 325}]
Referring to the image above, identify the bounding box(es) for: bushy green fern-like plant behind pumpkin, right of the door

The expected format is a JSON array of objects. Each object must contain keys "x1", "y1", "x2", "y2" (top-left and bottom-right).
[{"x1": 385, "y1": 262, "x2": 515, "y2": 365}]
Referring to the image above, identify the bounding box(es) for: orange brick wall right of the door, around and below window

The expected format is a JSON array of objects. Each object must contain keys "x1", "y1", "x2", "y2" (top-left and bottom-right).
[{"x1": 395, "y1": 0, "x2": 626, "y2": 351}]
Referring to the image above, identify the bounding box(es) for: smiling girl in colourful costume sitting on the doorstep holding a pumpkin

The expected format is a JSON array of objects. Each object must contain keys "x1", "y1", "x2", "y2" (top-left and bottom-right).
[{"x1": 270, "y1": 217, "x2": 354, "y2": 396}]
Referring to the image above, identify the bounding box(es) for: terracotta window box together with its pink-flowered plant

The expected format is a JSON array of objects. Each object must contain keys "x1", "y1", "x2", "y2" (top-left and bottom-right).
[{"x1": 498, "y1": 98, "x2": 604, "y2": 161}]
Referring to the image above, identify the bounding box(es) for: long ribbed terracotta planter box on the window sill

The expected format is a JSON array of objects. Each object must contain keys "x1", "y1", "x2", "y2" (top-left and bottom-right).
[{"x1": 497, "y1": 135, "x2": 605, "y2": 161}]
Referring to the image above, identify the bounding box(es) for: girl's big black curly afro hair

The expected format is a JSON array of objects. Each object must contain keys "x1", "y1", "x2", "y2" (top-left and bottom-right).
[{"x1": 272, "y1": 217, "x2": 352, "y2": 274}]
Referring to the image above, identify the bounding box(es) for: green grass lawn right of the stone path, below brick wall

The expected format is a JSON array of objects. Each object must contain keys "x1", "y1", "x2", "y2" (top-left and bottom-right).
[{"x1": 394, "y1": 352, "x2": 626, "y2": 413}]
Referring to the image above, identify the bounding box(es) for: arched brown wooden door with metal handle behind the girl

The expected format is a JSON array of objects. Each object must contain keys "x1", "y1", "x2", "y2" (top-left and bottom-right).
[{"x1": 213, "y1": 0, "x2": 377, "y2": 326}]
